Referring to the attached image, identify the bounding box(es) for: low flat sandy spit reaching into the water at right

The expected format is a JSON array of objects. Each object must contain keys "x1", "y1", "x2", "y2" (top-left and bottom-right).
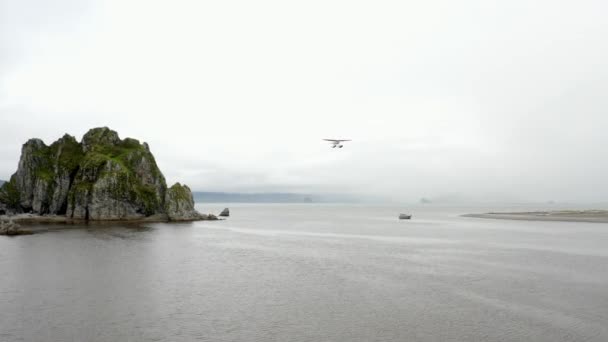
[{"x1": 461, "y1": 210, "x2": 608, "y2": 223}]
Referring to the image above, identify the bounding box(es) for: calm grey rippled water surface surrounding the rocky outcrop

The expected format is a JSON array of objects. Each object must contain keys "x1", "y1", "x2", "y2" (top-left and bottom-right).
[{"x1": 0, "y1": 205, "x2": 608, "y2": 341}]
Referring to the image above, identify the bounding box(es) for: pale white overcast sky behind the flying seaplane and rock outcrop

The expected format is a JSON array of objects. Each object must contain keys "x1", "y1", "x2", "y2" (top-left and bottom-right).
[{"x1": 0, "y1": 0, "x2": 608, "y2": 201}]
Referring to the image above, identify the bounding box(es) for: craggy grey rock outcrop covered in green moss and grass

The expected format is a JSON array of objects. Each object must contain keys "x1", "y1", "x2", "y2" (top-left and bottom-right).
[{"x1": 0, "y1": 127, "x2": 205, "y2": 221}]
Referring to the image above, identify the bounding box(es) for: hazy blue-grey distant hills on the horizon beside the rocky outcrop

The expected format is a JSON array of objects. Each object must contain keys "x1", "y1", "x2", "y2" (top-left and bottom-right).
[{"x1": 192, "y1": 191, "x2": 354, "y2": 203}]
